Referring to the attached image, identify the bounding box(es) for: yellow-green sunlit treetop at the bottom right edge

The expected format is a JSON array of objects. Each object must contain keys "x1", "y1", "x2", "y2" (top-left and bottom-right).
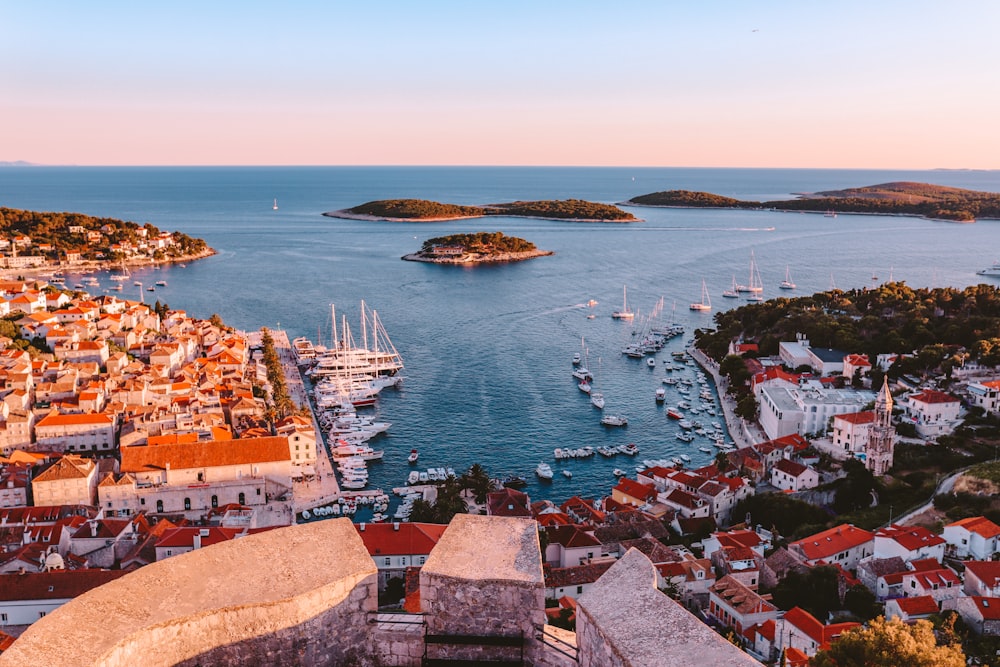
[{"x1": 809, "y1": 617, "x2": 965, "y2": 667}]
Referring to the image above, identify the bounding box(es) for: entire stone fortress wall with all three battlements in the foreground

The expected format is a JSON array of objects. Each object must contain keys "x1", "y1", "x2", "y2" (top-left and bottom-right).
[{"x1": 0, "y1": 515, "x2": 759, "y2": 667}]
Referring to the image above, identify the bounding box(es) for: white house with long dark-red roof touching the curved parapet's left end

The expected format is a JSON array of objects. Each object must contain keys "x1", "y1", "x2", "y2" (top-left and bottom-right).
[{"x1": 0, "y1": 569, "x2": 126, "y2": 625}]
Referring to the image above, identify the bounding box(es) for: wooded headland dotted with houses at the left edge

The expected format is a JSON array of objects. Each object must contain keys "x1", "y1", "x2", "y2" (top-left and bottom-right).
[{"x1": 0, "y1": 207, "x2": 215, "y2": 268}]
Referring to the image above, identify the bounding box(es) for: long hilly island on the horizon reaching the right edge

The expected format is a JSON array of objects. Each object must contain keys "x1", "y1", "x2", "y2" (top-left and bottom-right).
[{"x1": 625, "y1": 181, "x2": 1000, "y2": 222}]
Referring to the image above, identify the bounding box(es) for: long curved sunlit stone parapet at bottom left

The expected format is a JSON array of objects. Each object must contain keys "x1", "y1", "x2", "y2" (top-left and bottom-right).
[{"x1": 0, "y1": 519, "x2": 378, "y2": 667}]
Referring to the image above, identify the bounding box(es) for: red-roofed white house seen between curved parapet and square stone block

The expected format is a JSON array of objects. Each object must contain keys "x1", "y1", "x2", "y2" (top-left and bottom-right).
[{"x1": 354, "y1": 522, "x2": 448, "y2": 589}]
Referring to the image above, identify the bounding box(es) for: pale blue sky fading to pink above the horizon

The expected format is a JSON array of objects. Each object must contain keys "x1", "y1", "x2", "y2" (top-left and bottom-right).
[{"x1": 0, "y1": 0, "x2": 1000, "y2": 169}]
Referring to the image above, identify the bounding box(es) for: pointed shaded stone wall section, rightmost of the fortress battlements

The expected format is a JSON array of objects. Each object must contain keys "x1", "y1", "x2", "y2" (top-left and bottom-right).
[{"x1": 576, "y1": 549, "x2": 760, "y2": 667}]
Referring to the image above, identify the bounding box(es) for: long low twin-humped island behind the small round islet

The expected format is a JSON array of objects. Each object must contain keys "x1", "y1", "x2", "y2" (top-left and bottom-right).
[{"x1": 323, "y1": 199, "x2": 639, "y2": 222}]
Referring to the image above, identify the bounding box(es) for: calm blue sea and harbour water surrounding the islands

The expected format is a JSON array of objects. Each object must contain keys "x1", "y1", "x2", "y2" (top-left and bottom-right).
[{"x1": 0, "y1": 167, "x2": 1000, "y2": 500}]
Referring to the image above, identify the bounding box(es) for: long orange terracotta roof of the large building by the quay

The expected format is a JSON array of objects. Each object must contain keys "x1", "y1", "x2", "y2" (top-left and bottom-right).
[{"x1": 121, "y1": 436, "x2": 291, "y2": 472}]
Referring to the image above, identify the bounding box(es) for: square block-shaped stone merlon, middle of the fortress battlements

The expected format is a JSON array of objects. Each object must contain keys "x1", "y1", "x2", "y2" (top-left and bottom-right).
[{"x1": 420, "y1": 514, "x2": 545, "y2": 664}]
